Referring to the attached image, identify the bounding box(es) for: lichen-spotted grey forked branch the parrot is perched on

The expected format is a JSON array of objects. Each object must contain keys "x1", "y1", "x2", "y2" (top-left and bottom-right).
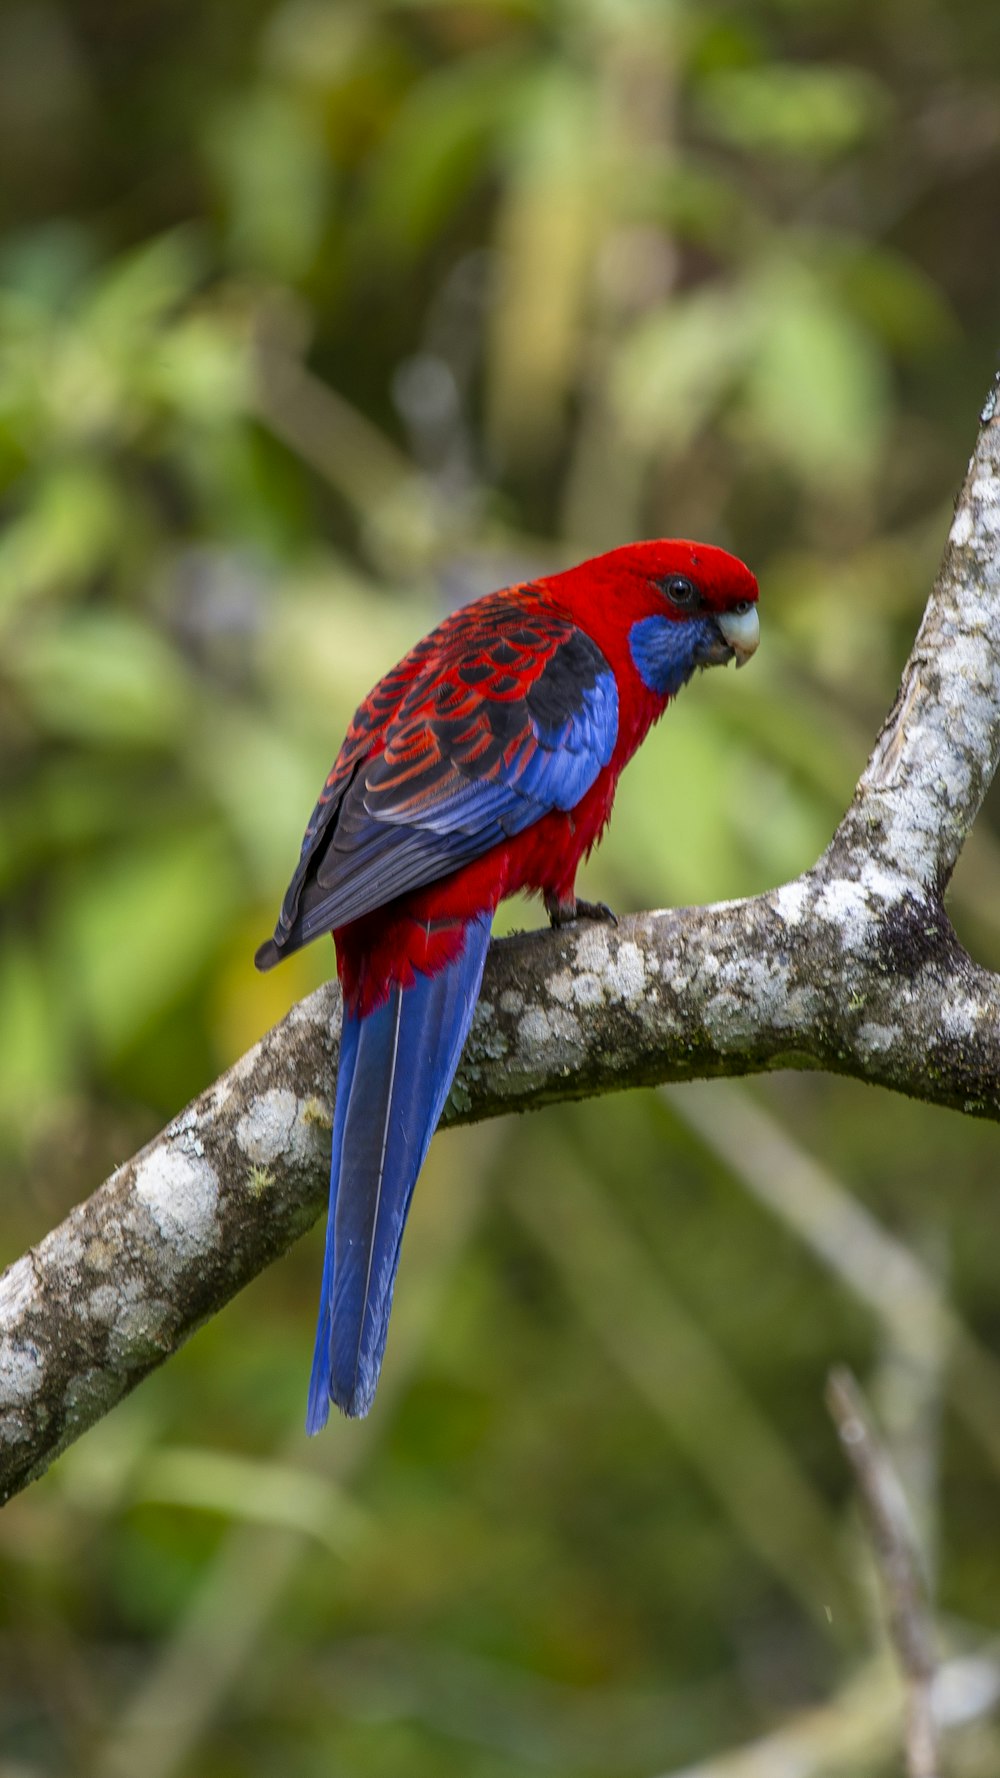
[{"x1": 0, "y1": 379, "x2": 1000, "y2": 1501}]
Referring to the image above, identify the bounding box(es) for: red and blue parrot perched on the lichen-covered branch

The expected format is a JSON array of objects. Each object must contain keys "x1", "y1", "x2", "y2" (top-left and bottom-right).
[{"x1": 256, "y1": 541, "x2": 758, "y2": 1433}]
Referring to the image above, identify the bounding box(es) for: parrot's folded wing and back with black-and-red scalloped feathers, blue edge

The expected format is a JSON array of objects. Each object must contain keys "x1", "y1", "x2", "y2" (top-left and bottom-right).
[{"x1": 256, "y1": 589, "x2": 617, "y2": 969}]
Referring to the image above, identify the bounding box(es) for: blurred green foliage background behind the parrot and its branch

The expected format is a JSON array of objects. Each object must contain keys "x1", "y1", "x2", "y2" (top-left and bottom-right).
[{"x1": 0, "y1": 0, "x2": 1000, "y2": 1778}]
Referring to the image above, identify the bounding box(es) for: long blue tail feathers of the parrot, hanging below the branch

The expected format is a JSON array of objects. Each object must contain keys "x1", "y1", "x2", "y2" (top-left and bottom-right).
[{"x1": 306, "y1": 914, "x2": 489, "y2": 1433}]
